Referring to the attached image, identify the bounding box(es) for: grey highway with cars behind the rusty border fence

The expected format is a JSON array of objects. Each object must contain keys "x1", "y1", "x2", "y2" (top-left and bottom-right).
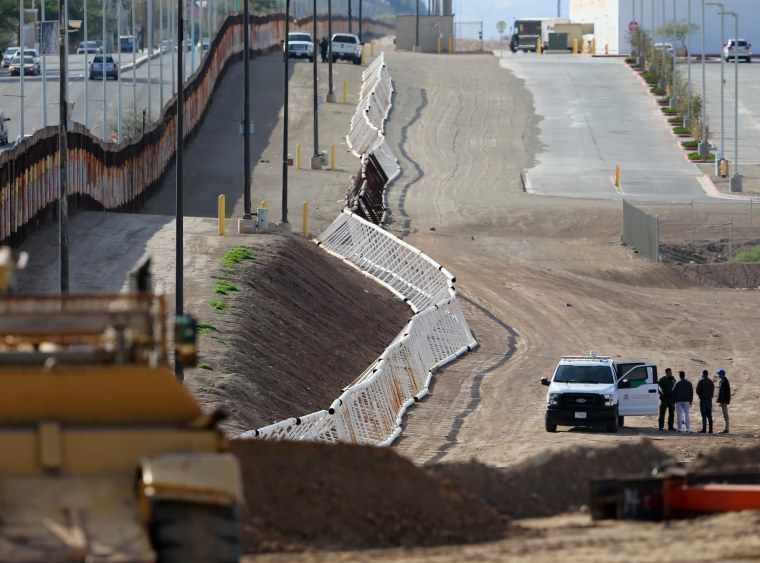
[{"x1": 0, "y1": 48, "x2": 201, "y2": 150}]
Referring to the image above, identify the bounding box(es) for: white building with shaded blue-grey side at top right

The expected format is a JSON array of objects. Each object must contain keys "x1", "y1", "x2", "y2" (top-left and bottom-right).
[{"x1": 569, "y1": 0, "x2": 760, "y2": 55}]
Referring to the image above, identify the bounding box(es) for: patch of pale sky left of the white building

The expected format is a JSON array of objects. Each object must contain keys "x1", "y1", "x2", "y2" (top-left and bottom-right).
[{"x1": 453, "y1": 0, "x2": 569, "y2": 39}]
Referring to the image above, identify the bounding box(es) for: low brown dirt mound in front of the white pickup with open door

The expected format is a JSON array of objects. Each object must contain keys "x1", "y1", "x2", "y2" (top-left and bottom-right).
[{"x1": 426, "y1": 440, "x2": 669, "y2": 518}]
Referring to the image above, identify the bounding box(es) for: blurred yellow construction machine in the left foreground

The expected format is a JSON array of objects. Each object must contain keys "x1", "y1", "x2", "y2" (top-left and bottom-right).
[{"x1": 0, "y1": 248, "x2": 243, "y2": 563}]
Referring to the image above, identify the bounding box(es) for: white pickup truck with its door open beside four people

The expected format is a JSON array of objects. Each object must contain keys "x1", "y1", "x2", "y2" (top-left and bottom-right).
[{"x1": 541, "y1": 352, "x2": 659, "y2": 432}]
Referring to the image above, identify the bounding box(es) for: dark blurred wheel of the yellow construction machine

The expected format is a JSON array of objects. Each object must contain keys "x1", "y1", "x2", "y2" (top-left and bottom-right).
[{"x1": 150, "y1": 502, "x2": 242, "y2": 563}]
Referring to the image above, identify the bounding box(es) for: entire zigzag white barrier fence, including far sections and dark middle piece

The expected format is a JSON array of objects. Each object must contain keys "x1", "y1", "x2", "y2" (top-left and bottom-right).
[{"x1": 239, "y1": 54, "x2": 477, "y2": 446}]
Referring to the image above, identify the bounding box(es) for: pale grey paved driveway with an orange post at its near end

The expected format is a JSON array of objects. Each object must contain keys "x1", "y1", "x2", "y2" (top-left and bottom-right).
[{"x1": 496, "y1": 51, "x2": 707, "y2": 200}]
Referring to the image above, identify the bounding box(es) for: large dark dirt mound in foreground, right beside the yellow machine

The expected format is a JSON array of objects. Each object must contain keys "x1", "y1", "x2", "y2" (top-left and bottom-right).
[{"x1": 232, "y1": 440, "x2": 507, "y2": 553}]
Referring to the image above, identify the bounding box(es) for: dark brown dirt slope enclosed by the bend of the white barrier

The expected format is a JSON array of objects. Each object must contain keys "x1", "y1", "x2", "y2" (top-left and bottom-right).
[{"x1": 187, "y1": 236, "x2": 412, "y2": 435}]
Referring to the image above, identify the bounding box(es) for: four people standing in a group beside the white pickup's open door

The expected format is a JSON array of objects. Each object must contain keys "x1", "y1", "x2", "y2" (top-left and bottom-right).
[{"x1": 658, "y1": 368, "x2": 731, "y2": 434}]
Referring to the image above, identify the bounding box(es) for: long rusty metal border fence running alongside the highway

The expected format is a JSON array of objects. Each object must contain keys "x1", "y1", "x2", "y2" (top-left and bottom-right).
[{"x1": 0, "y1": 14, "x2": 389, "y2": 248}]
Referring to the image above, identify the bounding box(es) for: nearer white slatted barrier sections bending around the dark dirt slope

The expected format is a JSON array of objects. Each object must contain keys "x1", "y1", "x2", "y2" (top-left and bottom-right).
[{"x1": 240, "y1": 213, "x2": 477, "y2": 446}]
